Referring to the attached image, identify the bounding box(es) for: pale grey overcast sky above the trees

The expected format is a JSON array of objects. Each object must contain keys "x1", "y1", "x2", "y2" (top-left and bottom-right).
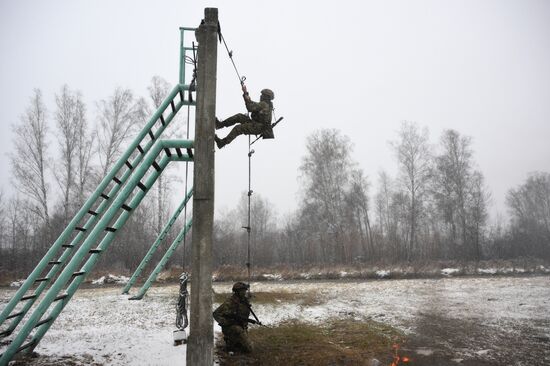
[{"x1": 0, "y1": 0, "x2": 550, "y2": 222}]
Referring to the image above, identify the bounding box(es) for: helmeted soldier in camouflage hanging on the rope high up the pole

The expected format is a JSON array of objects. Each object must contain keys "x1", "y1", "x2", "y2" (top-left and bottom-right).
[{"x1": 215, "y1": 84, "x2": 275, "y2": 149}]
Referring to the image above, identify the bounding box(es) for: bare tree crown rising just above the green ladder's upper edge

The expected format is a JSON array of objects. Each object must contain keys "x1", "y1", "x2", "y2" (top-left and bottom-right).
[{"x1": 96, "y1": 88, "x2": 146, "y2": 177}]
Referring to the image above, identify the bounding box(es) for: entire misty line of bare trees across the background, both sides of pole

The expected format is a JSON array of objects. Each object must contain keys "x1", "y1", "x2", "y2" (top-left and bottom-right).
[{"x1": 0, "y1": 85, "x2": 550, "y2": 275}]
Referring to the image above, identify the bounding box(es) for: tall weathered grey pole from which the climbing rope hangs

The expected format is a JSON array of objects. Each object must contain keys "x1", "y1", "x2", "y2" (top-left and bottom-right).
[{"x1": 187, "y1": 8, "x2": 218, "y2": 366}]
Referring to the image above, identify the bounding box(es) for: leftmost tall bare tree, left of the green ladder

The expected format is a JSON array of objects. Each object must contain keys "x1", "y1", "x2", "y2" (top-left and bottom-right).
[{"x1": 10, "y1": 89, "x2": 50, "y2": 226}]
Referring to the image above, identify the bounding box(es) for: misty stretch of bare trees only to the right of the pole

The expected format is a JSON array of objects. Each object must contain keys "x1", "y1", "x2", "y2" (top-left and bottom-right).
[{"x1": 215, "y1": 126, "x2": 550, "y2": 266}]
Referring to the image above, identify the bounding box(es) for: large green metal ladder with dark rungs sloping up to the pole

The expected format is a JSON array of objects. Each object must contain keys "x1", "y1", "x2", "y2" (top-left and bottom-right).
[{"x1": 0, "y1": 28, "x2": 195, "y2": 366}]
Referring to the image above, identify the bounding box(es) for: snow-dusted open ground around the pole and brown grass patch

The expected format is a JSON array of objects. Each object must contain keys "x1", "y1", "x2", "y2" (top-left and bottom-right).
[{"x1": 0, "y1": 276, "x2": 550, "y2": 365}]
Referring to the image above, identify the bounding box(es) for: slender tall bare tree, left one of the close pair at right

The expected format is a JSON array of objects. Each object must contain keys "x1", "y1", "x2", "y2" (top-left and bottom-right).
[{"x1": 392, "y1": 122, "x2": 432, "y2": 261}]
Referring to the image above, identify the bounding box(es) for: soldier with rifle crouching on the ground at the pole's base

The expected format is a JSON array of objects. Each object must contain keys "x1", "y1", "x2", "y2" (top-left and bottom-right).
[{"x1": 213, "y1": 282, "x2": 257, "y2": 353}]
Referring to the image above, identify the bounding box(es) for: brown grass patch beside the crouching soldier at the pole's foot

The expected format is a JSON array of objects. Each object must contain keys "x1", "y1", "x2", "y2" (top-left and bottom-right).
[{"x1": 216, "y1": 320, "x2": 403, "y2": 366}]
